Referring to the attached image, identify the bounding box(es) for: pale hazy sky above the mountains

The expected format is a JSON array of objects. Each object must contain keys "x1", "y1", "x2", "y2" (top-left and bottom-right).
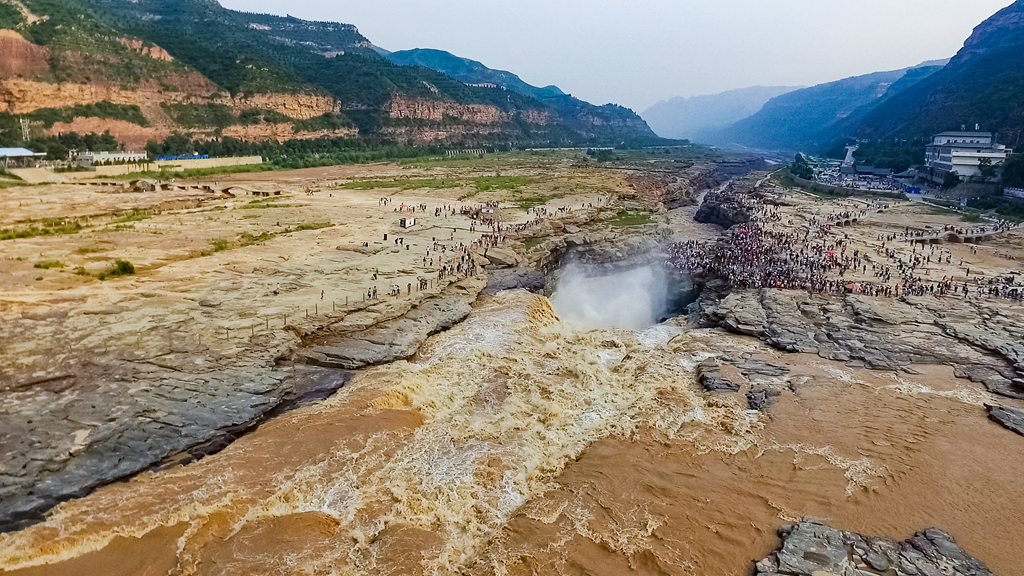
[{"x1": 221, "y1": 0, "x2": 1012, "y2": 112}]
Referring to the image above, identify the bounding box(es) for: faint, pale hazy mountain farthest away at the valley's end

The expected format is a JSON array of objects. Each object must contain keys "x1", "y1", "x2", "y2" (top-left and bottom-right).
[{"x1": 640, "y1": 86, "x2": 802, "y2": 141}]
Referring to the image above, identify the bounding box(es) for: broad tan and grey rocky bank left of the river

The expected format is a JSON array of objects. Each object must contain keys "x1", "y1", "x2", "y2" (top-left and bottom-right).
[{"x1": 0, "y1": 150, "x2": 755, "y2": 530}]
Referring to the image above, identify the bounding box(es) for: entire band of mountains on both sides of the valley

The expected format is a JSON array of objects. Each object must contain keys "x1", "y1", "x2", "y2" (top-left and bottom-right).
[{"x1": 0, "y1": 0, "x2": 1024, "y2": 153}]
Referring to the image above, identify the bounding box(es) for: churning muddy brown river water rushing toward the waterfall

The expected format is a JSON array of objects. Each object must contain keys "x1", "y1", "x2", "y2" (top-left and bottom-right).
[{"x1": 0, "y1": 291, "x2": 1024, "y2": 576}]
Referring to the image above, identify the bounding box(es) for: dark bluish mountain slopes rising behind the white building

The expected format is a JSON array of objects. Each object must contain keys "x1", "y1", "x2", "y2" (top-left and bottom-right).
[{"x1": 684, "y1": 0, "x2": 1024, "y2": 155}]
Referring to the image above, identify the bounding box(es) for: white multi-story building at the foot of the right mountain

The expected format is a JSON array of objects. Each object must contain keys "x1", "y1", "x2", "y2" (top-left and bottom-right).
[{"x1": 925, "y1": 132, "x2": 1013, "y2": 183}]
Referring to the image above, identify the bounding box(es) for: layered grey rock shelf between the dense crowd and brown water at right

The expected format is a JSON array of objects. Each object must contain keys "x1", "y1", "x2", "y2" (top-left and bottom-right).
[{"x1": 698, "y1": 289, "x2": 1024, "y2": 399}]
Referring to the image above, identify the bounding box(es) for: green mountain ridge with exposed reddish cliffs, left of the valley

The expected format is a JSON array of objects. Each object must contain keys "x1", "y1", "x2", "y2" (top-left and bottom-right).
[{"x1": 0, "y1": 0, "x2": 666, "y2": 147}]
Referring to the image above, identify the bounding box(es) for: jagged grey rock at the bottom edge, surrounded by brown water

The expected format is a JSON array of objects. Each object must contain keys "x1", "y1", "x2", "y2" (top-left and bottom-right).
[{"x1": 756, "y1": 519, "x2": 993, "y2": 576}]
